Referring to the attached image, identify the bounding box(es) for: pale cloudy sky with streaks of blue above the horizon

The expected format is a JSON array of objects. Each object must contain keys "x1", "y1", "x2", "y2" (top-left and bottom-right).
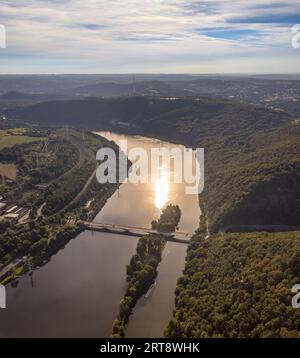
[{"x1": 0, "y1": 0, "x2": 300, "y2": 74}]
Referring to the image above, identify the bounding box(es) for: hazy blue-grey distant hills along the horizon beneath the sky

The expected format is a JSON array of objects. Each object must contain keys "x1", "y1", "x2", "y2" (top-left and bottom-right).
[{"x1": 0, "y1": 75, "x2": 300, "y2": 117}]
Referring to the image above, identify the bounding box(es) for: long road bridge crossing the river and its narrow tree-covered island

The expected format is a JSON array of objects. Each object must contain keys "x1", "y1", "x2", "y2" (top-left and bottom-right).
[{"x1": 79, "y1": 221, "x2": 193, "y2": 244}]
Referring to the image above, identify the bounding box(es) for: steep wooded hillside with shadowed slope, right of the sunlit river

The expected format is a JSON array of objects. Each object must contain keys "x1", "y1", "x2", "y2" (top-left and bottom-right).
[{"x1": 203, "y1": 123, "x2": 300, "y2": 231}]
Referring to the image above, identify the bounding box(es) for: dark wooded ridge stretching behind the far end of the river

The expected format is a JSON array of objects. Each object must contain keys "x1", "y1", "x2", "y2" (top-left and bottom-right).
[{"x1": 8, "y1": 97, "x2": 290, "y2": 136}]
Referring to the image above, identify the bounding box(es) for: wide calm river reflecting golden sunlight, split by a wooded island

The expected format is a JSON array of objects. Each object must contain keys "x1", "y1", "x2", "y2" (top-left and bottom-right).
[{"x1": 0, "y1": 132, "x2": 200, "y2": 337}]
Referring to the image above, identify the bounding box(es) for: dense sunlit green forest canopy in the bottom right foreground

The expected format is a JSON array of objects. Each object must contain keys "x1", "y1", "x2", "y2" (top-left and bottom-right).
[{"x1": 165, "y1": 232, "x2": 300, "y2": 338}]
